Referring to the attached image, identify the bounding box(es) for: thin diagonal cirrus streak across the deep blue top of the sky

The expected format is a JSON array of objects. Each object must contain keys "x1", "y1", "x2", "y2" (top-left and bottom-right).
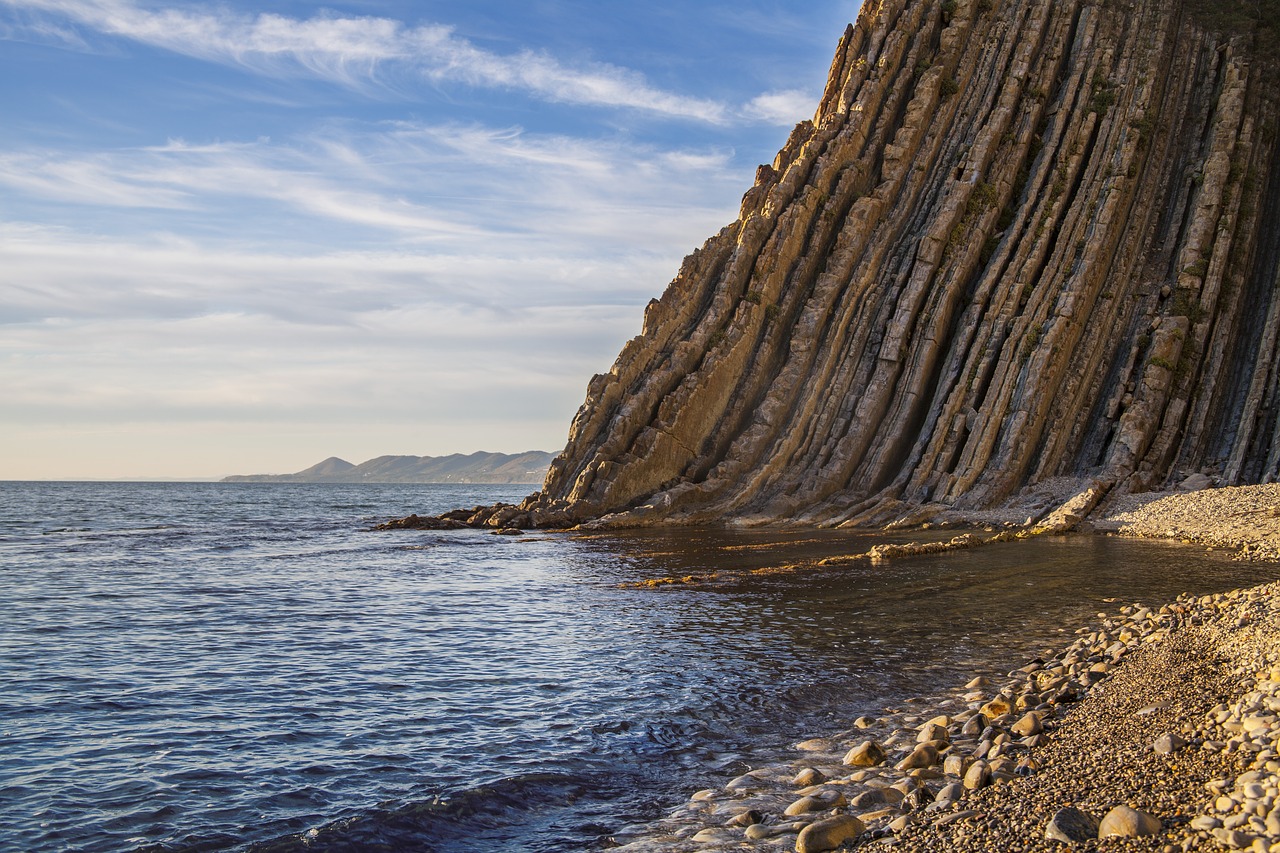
[{"x1": 0, "y1": 0, "x2": 732, "y2": 124}]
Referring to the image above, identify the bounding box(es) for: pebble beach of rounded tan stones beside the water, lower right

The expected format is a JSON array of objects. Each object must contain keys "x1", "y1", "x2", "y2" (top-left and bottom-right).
[{"x1": 606, "y1": 485, "x2": 1280, "y2": 853}]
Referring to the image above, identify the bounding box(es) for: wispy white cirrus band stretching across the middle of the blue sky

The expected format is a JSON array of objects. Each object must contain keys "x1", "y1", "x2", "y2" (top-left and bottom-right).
[{"x1": 0, "y1": 122, "x2": 749, "y2": 256}]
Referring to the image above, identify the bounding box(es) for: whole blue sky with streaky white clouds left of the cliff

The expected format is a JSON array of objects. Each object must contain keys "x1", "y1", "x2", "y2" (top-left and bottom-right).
[{"x1": 0, "y1": 0, "x2": 858, "y2": 480}]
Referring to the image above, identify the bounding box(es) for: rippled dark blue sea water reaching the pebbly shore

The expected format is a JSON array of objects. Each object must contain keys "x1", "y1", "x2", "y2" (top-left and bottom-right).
[{"x1": 0, "y1": 483, "x2": 1276, "y2": 852}]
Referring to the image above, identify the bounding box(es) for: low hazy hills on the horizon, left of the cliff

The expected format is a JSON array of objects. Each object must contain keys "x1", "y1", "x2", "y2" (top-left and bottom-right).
[{"x1": 223, "y1": 451, "x2": 556, "y2": 485}]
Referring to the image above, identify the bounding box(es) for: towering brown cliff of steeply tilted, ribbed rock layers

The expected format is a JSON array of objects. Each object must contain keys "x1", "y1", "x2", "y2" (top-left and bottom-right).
[{"x1": 522, "y1": 0, "x2": 1280, "y2": 525}]
